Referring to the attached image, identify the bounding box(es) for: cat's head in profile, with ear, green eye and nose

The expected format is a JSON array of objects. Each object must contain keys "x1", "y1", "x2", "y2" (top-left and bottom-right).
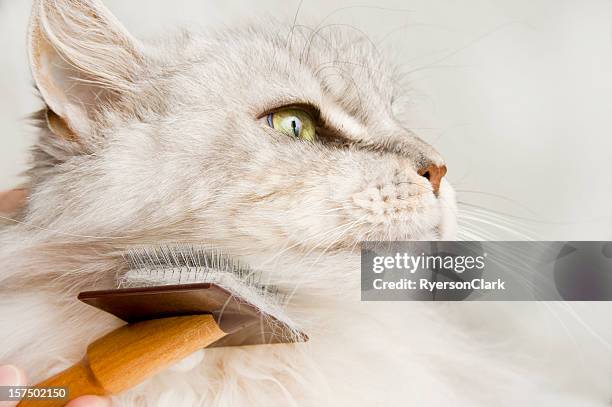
[{"x1": 22, "y1": 0, "x2": 455, "y2": 262}]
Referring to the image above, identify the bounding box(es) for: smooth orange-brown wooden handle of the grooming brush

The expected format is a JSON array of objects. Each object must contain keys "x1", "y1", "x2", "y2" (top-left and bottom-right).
[{"x1": 18, "y1": 315, "x2": 227, "y2": 407}]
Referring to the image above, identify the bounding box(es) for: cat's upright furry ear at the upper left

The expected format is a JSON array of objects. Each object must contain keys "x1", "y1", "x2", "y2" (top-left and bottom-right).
[{"x1": 28, "y1": 0, "x2": 143, "y2": 138}]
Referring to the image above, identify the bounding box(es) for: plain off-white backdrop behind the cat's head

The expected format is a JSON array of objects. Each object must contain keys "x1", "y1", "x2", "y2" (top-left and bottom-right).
[{"x1": 0, "y1": 0, "x2": 612, "y2": 240}]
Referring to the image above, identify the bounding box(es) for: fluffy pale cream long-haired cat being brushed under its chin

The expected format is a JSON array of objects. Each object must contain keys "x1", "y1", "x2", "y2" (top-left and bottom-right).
[{"x1": 0, "y1": 0, "x2": 605, "y2": 406}]
